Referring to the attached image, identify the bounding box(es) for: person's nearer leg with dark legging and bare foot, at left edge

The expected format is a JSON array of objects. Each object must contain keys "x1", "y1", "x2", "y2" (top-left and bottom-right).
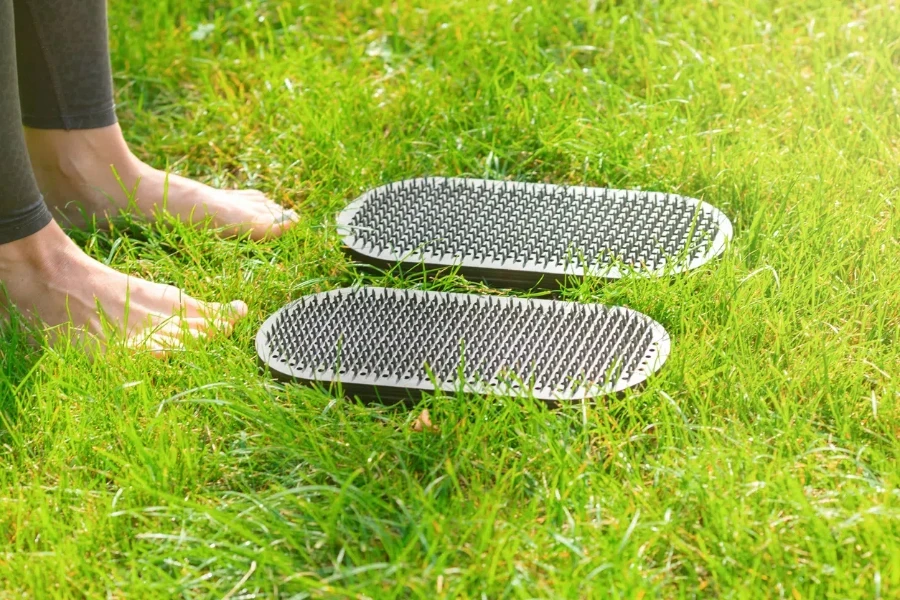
[{"x1": 0, "y1": 0, "x2": 246, "y2": 354}]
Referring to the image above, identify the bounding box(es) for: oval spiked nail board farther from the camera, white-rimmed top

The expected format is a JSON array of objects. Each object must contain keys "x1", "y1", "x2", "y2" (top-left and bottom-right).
[{"x1": 337, "y1": 177, "x2": 732, "y2": 288}]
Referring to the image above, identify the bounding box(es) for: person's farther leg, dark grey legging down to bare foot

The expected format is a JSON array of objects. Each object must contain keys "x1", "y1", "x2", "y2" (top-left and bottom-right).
[{"x1": 14, "y1": 0, "x2": 297, "y2": 239}]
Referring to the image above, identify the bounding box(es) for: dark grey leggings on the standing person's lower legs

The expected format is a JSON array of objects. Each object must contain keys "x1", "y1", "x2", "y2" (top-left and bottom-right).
[{"x1": 0, "y1": 0, "x2": 116, "y2": 244}]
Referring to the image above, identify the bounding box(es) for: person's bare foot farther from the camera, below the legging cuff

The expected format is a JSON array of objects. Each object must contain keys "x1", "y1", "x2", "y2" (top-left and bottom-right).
[{"x1": 25, "y1": 125, "x2": 297, "y2": 240}]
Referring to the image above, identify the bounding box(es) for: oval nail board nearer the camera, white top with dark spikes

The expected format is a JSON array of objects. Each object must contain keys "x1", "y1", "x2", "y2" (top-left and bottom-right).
[{"x1": 256, "y1": 287, "x2": 669, "y2": 402}]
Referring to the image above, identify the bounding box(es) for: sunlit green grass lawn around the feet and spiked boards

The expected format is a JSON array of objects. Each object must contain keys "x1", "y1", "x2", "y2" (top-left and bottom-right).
[{"x1": 0, "y1": 0, "x2": 900, "y2": 600}]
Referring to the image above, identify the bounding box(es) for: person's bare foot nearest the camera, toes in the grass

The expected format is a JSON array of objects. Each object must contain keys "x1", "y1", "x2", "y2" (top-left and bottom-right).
[{"x1": 0, "y1": 222, "x2": 247, "y2": 356}]
